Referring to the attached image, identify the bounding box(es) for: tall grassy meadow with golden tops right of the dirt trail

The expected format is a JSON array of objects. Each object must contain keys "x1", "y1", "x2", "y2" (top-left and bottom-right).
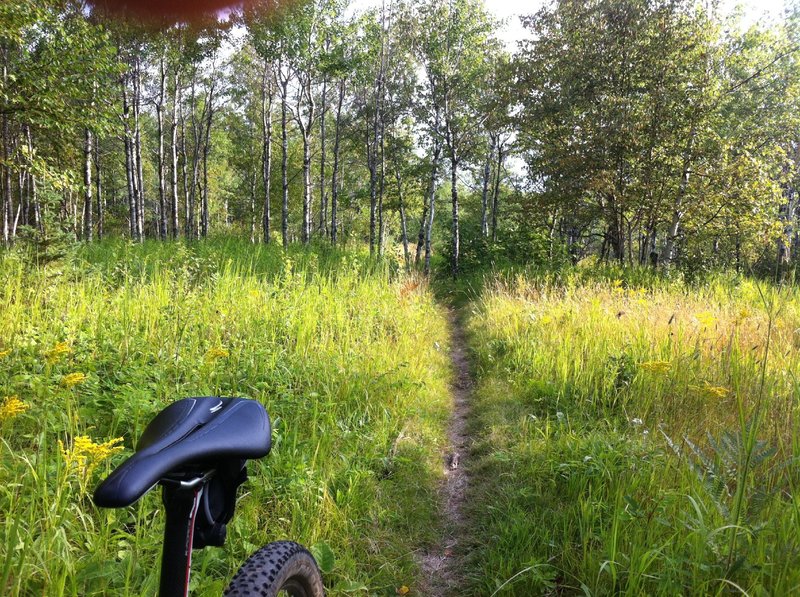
[{"x1": 468, "y1": 277, "x2": 800, "y2": 595}]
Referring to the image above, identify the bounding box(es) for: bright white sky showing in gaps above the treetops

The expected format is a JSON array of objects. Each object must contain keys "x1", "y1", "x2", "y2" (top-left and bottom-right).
[{"x1": 351, "y1": 0, "x2": 784, "y2": 49}]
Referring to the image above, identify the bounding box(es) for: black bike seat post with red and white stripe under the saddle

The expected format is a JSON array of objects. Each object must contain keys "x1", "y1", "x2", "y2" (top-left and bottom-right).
[{"x1": 158, "y1": 481, "x2": 205, "y2": 597}]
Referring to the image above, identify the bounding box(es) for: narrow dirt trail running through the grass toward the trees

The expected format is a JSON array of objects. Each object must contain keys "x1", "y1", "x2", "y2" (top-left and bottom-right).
[{"x1": 419, "y1": 309, "x2": 473, "y2": 597}]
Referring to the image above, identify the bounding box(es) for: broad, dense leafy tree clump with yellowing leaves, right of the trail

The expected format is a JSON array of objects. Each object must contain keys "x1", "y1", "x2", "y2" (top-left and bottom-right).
[{"x1": 514, "y1": 0, "x2": 798, "y2": 270}]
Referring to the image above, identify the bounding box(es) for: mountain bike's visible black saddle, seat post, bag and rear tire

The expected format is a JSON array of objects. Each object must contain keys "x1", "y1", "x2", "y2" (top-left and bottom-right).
[{"x1": 93, "y1": 397, "x2": 325, "y2": 597}]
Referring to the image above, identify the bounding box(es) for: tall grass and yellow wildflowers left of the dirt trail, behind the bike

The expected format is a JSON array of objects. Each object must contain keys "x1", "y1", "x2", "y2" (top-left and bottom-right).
[{"x1": 0, "y1": 239, "x2": 450, "y2": 595}]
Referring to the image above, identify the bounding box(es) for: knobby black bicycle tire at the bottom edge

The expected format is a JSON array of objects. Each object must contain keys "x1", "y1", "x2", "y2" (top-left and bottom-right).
[{"x1": 224, "y1": 541, "x2": 325, "y2": 597}]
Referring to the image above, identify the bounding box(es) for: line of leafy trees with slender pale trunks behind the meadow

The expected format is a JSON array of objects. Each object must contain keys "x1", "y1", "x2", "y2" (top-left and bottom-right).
[{"x1": 0, "y1": 0, "x2": 800, "y2": 276}]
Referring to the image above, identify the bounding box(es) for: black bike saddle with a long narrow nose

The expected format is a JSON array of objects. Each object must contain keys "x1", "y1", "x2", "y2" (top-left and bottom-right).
[{"x1": 94, "y1": 398, "x2": 271, "y2": 508}]
